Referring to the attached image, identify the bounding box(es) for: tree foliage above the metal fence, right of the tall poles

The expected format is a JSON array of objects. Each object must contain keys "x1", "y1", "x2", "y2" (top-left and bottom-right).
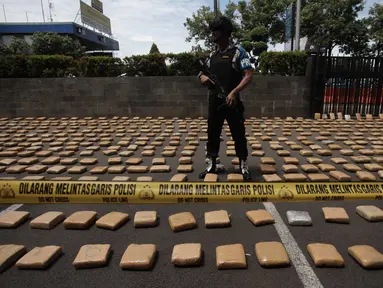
[{"x1": 302, "y1": 0, "x2": 383, "y2": 56}]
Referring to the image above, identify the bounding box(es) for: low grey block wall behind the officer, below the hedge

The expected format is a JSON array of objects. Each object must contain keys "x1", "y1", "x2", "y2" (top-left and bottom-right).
[{"x1": 0, "y1": 76, "x2": 310, "y2": 118}]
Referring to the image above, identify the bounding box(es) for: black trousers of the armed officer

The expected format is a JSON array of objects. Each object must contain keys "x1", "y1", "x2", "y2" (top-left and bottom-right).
[{"x1": 207, "y1": 93, "x2": 248, "y2": 160}]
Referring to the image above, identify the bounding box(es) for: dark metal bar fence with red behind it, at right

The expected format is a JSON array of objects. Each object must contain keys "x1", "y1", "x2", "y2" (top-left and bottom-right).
[{"x1": 318, "y1": 56, "x2": 383, "y2": 115}]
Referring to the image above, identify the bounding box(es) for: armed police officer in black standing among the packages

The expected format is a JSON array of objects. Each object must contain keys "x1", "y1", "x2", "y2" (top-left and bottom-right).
[{"x1": 198, "y1": 16, "x2": 252, "y2": 181}]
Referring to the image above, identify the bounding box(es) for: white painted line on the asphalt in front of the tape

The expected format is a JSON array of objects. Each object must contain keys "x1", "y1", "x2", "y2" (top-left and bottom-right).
[{"x1": 263, "y1": 203, "x2": 323, "y2": 288}]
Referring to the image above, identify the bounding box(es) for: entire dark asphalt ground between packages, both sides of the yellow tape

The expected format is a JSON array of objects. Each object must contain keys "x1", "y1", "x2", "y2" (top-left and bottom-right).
[{"x1": 0, "y1": 116, "x2": 383, "y2": 288}]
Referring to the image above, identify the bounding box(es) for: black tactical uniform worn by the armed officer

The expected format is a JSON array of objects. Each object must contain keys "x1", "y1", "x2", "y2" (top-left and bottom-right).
[{"x1": 199, "y1": 15, "x2": 251, "y2": 180}]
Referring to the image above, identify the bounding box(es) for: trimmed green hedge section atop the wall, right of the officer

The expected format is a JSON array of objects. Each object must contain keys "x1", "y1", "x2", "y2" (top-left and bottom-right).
[{"x1": 259, "y1": 51, "x2": 307, "y2": 76}]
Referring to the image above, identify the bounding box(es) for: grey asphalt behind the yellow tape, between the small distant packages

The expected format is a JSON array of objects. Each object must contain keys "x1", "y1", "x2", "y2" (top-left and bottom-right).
[{"x1": 0, "y1": 119, "x2": 383, "y2": 181}]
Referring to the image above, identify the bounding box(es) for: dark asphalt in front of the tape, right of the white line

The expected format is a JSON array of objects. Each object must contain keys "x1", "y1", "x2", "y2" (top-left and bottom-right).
[{"x1": 275, "y1": 201, "x2": 383, "y2": 288}]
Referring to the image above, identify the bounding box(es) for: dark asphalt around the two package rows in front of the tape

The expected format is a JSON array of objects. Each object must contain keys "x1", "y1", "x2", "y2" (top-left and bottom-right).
[{"x1": 0, "y1": 201, "x2": 383, "y2": 288}]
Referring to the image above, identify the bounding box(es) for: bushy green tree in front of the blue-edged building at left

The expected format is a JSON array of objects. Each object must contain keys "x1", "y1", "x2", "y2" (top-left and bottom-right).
[{"x1": 32, "y1": 32, "x2": 85, "y2": 58}]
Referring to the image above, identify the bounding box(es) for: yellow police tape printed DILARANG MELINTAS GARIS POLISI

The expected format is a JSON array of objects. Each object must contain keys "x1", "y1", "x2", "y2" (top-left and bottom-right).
[{"x1": 0, "y1": 180, "x2": 383, "y2": 204}]
